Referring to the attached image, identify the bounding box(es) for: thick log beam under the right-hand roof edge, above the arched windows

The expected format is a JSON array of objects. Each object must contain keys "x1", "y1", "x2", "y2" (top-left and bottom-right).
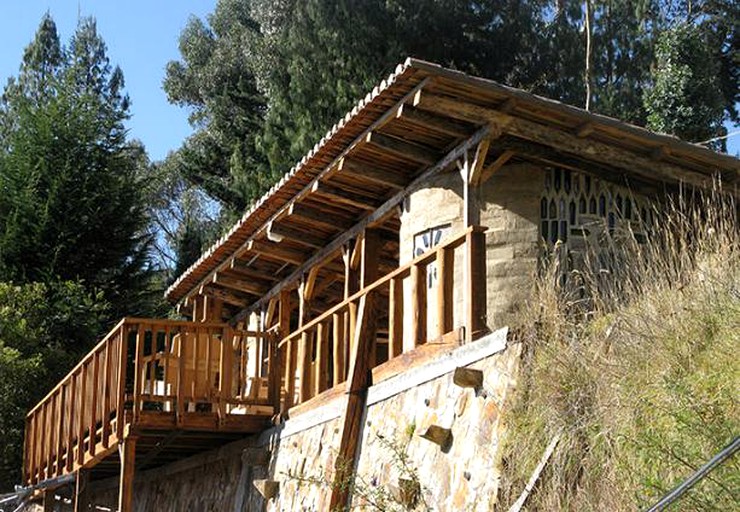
[{"x1": 416, "y1": 93, "x2": 712, "y2": 188}]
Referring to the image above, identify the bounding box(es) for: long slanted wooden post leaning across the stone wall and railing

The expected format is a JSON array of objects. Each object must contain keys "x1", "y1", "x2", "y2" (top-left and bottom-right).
[{"x1": 329, "y1": 291, "x2": 377, "y2": 510}]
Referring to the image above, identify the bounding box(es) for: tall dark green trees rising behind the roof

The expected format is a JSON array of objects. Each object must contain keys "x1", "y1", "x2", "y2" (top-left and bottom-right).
[{"x1": 164, "y1": 0, "x2": 740, "y2": 228}]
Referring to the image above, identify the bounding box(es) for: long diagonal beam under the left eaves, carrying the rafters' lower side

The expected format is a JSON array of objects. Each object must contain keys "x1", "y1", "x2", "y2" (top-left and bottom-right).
[{"x1": 232, "y1": 125, "x2": 490, "y2": 322}]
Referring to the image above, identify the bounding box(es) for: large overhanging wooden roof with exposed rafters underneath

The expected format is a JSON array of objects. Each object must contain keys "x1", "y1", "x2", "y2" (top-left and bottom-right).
[{"x1": 165, "y1": 59, "x2": 740, "y2": 308}]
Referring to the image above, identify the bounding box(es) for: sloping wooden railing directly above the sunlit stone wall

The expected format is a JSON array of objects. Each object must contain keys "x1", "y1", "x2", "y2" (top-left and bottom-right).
[{"x1": 279, "y1": 226, "x2": 486, "y2": 408}]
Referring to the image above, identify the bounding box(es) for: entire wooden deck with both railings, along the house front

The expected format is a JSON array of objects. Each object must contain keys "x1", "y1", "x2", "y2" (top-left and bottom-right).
[{"x1": 23, "y1": 226, "x2": 486, "y2": 511}]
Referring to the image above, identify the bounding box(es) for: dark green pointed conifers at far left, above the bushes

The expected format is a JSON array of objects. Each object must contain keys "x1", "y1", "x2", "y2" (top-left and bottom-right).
[{"x1": 0, "y1": 16, "x2": 161, "y2": 316}]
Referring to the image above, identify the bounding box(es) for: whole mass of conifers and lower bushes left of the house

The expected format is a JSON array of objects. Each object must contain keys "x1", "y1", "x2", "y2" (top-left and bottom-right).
[{"x1": 0, "y1": 15, "x2": 161, "y2": 491}]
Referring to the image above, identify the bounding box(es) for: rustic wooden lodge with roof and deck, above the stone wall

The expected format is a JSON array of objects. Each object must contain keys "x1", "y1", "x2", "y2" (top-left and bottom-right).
[{"x1": 23, "y1": 59, "x2": 740, "y2": 512}]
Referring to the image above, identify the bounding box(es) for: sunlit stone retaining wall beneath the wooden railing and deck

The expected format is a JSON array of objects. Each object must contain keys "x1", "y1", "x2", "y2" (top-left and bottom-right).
[{"x1": 88, "y1": 329, "x2": 520, "y2": 512}]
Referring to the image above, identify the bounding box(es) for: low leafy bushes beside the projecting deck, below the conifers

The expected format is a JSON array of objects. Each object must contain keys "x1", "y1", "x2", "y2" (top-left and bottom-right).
[{"x1": 0, "y1": 282, "x2": 108, "y2": 492}]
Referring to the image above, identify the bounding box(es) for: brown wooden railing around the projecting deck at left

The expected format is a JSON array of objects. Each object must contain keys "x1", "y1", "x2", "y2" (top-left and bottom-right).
[{"x1": 23, "y1": 318, "x2": 274, "y2": 484}]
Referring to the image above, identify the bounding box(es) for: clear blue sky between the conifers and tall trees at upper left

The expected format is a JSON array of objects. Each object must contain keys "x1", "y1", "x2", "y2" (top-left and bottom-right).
[{"x1": 0, "y1": 0, "x2": 216, "y2": 160}]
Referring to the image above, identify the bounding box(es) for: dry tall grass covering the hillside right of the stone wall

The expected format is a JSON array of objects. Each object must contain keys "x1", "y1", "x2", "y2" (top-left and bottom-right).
[{"x1": 500, "y1": 192, "x2": 740, "y2": 511}]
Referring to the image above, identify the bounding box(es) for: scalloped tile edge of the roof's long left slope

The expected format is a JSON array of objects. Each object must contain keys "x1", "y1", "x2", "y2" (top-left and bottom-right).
[{"x1": 164, "y1": 58, "x2": 418, "y2": 301}]
